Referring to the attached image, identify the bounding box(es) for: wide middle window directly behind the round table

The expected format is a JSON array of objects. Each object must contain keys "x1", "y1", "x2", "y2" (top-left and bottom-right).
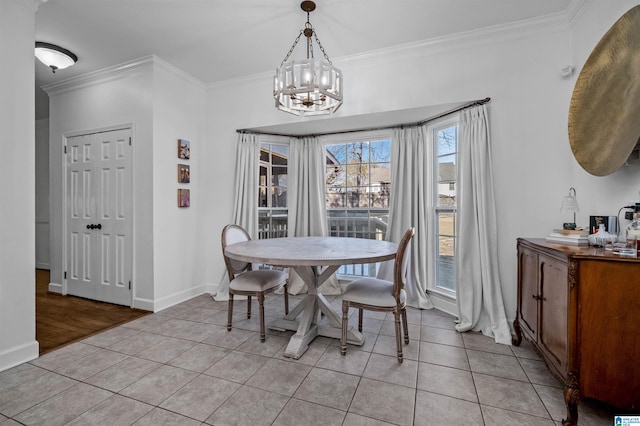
[{"x1": 326, "y1": 135, "x2": 391, "y2": 276}]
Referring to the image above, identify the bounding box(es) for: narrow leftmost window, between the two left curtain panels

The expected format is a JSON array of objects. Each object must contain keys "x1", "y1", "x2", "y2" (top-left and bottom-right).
[{"x1": 258, "y1": 143, "x2": 289, "y2": 239}]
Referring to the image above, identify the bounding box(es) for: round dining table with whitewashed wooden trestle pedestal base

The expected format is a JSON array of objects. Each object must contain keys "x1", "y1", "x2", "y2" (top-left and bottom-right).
[{"x1": 225, "y1": 237, "x2": 398, "y2": 359}]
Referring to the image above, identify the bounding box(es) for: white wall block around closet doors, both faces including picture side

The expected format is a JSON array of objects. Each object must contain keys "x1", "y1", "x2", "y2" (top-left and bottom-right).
[{"x1": 45, "y1": 57, "x2": 214, "y2": 311}]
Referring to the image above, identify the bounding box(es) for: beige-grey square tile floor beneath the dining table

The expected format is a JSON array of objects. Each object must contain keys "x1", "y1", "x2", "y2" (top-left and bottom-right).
[{"x1": 0, "y1": 295, "x2": 614, "y2": 426}]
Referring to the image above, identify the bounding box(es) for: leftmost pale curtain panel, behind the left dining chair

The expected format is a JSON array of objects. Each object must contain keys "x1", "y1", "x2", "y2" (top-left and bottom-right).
[{"x1": 213, "y1": 133, "x2": 260, "y2": 301}]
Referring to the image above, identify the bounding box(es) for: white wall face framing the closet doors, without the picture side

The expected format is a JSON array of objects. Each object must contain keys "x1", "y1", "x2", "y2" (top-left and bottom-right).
[{"x1": 47, "y1": 59, "x2": 154, "y2": 310}]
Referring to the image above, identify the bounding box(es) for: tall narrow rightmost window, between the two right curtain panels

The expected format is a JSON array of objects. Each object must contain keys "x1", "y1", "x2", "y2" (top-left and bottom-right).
[{"x1": 432, "y1": 120, "x2": 458, "y2": 295}]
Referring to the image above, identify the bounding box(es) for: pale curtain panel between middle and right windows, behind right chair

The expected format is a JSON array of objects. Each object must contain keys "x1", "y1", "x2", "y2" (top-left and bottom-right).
[{"x1": 378, "y1": 126, "x2": 433, "y2": 309}]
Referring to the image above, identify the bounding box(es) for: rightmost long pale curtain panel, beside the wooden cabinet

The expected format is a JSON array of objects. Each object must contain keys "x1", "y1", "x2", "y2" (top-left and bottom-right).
[{"x1": 456, "y1": 105, "x2": 511, "y2": 345}]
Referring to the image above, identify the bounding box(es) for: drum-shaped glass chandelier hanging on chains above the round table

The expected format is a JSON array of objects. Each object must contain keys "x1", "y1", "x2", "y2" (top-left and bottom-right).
[{"x1": 273, "y1": 1, "x2": 342, "y2": 115}]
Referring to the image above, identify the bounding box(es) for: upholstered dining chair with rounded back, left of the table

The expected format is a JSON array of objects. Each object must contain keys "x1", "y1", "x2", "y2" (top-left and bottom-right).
[{"x1": 222, "y1": 225, "x2": 289, "y2": 342}]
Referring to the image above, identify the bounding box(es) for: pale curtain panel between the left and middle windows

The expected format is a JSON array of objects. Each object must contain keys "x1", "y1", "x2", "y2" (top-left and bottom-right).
[{"x1": 287, "y1": 137, "x2": 342, "y2": 294}]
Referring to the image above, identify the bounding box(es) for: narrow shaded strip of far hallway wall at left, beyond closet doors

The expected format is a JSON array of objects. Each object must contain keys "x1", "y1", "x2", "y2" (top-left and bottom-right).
[{"x1": 36, "y1": 118, "x2": 49, "y2": 269}]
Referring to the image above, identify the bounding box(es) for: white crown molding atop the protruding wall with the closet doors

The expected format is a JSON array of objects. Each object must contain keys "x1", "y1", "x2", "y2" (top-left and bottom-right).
[{"x1": 42, "y1": 55, "x2": 205, "y2": 96}]
